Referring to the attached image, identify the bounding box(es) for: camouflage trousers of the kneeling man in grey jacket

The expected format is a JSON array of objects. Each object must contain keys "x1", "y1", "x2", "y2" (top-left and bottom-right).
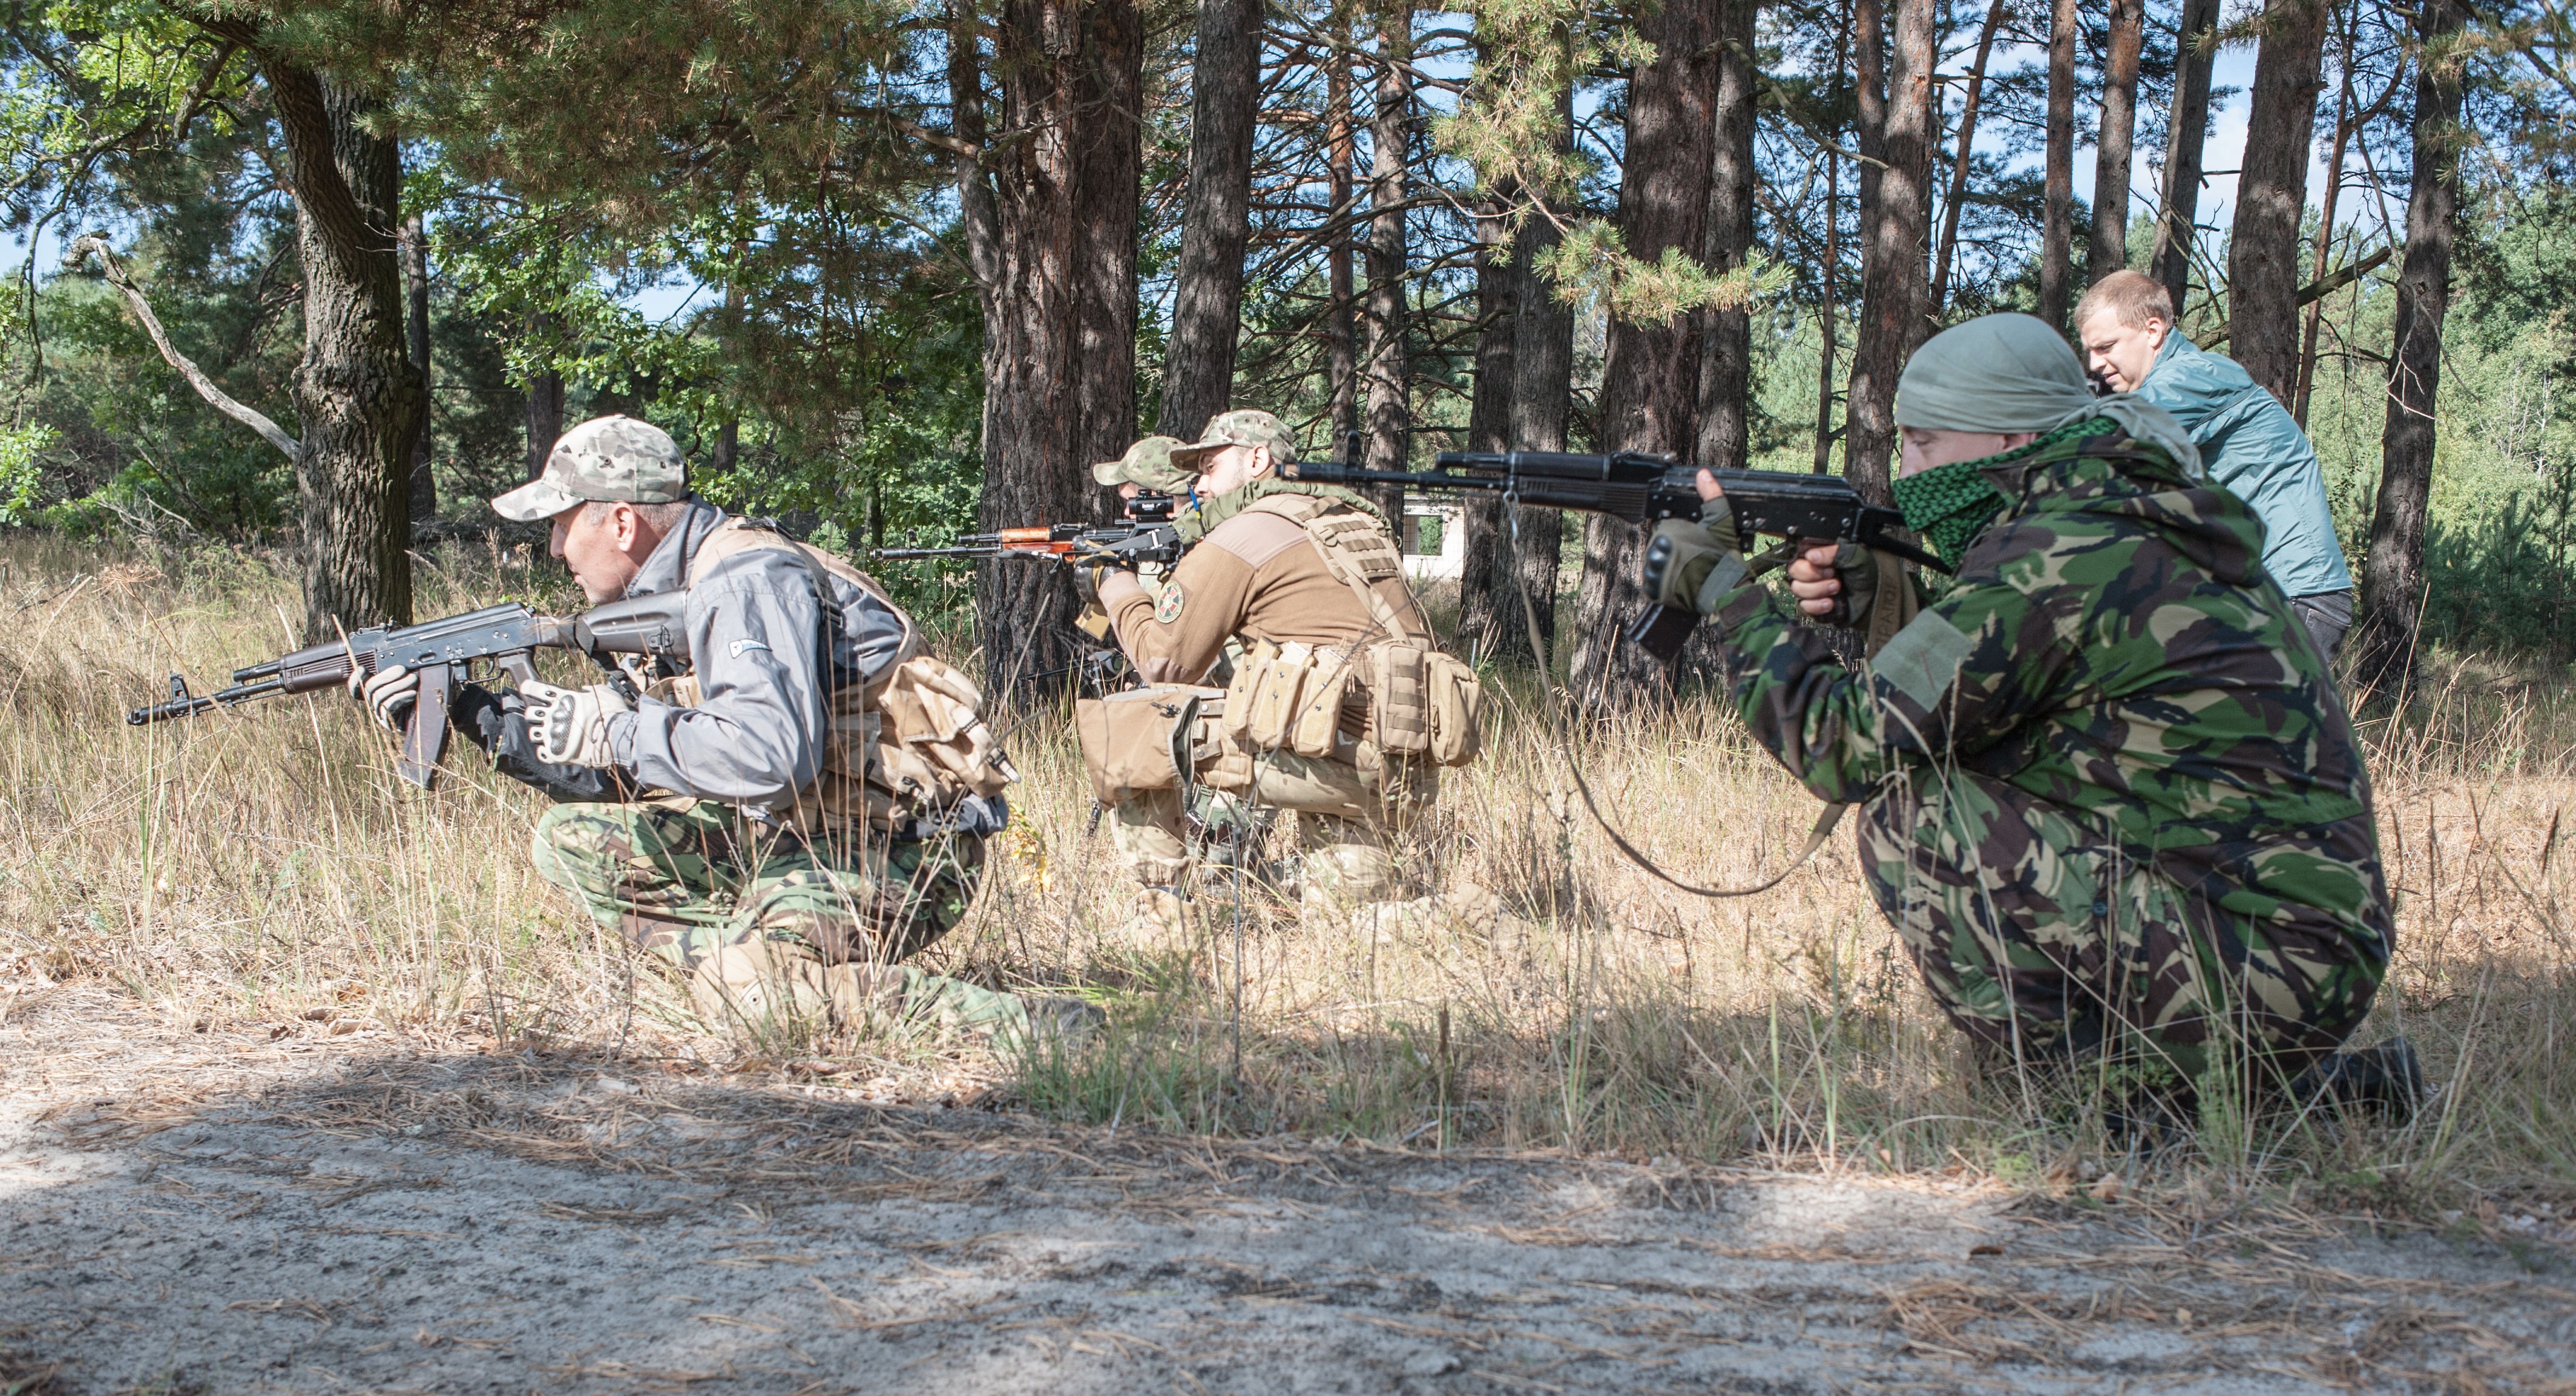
[{"x1": 528, "y1": 801, "x2": 1025, "y2": 1031}]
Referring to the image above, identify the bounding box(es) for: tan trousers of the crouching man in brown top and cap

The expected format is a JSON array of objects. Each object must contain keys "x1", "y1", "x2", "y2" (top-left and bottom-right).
[{"x1": 1110, "y1": 742, "x2": 1440, "y2": 902}]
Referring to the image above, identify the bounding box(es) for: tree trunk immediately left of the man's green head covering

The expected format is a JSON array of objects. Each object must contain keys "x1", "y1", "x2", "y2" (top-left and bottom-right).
[{"x1": 1842, "y1": 0, "x2": 1940, "y2": 502}]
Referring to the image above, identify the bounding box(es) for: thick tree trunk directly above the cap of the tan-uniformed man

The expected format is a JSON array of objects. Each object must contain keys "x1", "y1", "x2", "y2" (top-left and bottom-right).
[{"x1": 1159, "y1": 0, "x2": 1262, "y2": 437}]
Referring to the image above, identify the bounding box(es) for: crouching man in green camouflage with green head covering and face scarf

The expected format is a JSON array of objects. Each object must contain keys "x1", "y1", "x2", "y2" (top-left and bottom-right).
[{"x1": 1646, "y1": 314, "x2": 2393, "y2": 1107}]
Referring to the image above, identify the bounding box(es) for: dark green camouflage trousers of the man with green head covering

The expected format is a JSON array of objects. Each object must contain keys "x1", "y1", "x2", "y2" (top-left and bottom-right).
[{"x1": 1860, "y1": 773, "x2": 2388, "y2": 1079}]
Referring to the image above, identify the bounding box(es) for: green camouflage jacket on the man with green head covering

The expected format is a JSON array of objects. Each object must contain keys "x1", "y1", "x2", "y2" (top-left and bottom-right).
[{"x1": 1700, "y1": 420, "x2": 2391, "y2": 961}]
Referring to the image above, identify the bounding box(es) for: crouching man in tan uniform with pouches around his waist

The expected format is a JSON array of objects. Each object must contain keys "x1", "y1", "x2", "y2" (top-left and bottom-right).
[{"x1": 1100, "y1": 412, "x2": 1473, "y2": 920}]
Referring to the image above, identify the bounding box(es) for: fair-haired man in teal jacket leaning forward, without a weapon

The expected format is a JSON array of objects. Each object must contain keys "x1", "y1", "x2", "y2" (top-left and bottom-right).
[{"x1": 2076, "y1": 270, "x2": 2352, "y2": 662}]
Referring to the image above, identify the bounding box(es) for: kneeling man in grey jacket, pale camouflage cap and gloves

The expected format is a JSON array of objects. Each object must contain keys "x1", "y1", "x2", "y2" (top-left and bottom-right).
[{"x1": 363, "y1": 418, "x2": 1079, "y2": 1046}]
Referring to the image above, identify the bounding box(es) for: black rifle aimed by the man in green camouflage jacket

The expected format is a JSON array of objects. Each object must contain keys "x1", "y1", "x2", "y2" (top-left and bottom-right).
[{"x1": 1286, "y1": 451, "x2": 1950, "y2": 660}]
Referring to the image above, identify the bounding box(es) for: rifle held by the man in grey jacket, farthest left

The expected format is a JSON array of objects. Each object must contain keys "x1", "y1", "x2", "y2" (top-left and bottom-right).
[{"x1": 126, "y1": 592, "x2": 688, "y2": 791}]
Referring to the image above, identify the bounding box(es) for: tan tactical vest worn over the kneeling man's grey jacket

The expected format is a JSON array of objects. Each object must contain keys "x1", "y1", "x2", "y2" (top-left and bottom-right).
[{"x1": 652, "y1": 518, "x2": 1020, "y2": 830}]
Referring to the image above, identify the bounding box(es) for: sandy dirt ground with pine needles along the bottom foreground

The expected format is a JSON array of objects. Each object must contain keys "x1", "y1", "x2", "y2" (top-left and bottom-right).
[{"x1": 0, "y1": 986, "x2": 2576, "y2": 1396}]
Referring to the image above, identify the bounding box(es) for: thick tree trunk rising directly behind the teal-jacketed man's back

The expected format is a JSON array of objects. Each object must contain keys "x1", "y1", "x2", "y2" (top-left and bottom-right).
[{"x1": 2228, "y1": 0, "x2": 2326, "y2": 407}]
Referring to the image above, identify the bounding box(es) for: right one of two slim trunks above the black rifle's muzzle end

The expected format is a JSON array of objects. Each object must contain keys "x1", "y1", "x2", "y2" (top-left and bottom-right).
[{"x1": 1368, "y1": 0, "x2": 1414, "y2": 491}]
